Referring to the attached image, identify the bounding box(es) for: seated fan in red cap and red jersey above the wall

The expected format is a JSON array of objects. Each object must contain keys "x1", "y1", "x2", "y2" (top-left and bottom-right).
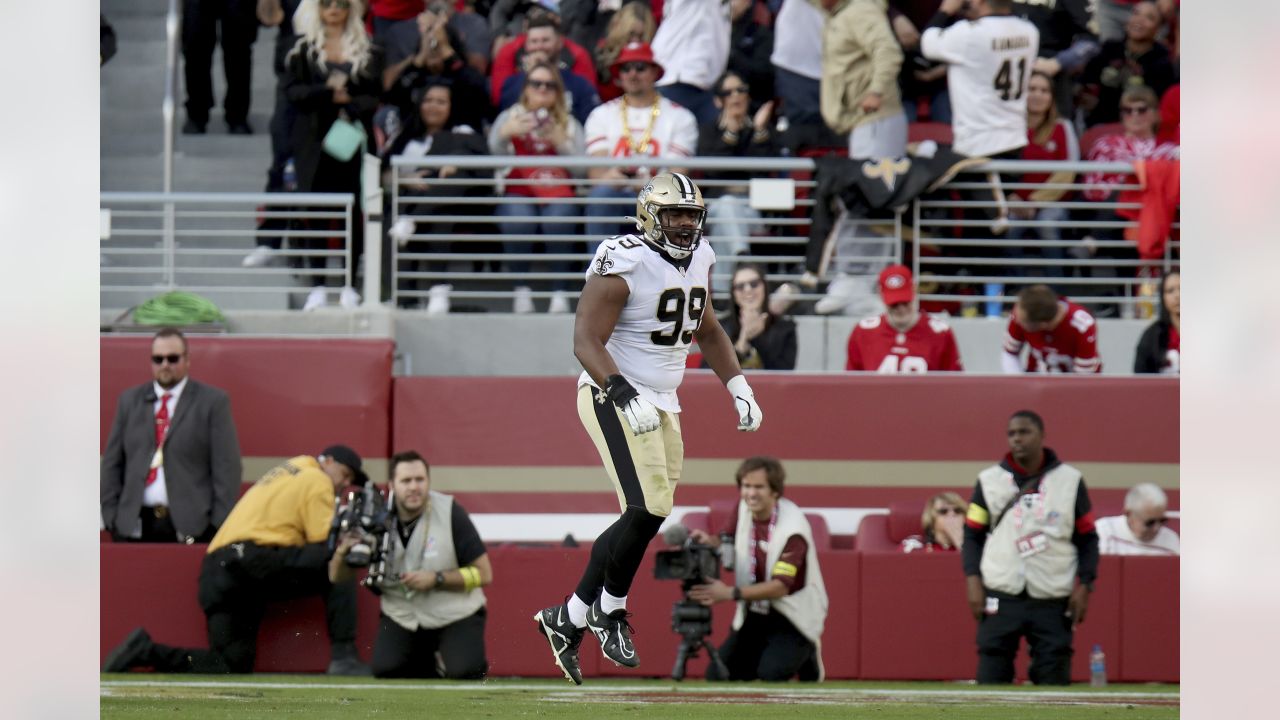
[{"x1": 845, "y1": 265, "x2": 964, "y2": 373}]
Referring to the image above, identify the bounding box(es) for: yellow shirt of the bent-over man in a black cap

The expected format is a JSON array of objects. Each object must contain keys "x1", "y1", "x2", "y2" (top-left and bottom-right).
[{"x1": 209, "y1": 455, "x2": 334, "y2": 552}]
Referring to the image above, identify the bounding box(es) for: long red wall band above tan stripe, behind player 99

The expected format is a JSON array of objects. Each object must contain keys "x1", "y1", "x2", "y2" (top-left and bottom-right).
[{"x1": 392, "y1": 372, "x2": 1179, "y2": 466}]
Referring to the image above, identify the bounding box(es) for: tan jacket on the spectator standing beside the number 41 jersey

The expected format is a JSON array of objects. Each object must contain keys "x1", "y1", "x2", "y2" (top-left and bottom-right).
[{"x1": 810, "y1": 0, "x2": 902, "y2": 133}]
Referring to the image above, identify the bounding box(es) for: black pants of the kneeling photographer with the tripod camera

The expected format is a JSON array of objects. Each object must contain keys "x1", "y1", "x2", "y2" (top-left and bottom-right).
[{"x1": 708, "y1": 604, "x2": 818, "y2": 682}]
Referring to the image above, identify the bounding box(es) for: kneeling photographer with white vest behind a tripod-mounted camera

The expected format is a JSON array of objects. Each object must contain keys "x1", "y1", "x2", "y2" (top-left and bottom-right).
[{"x1": 689, "y1": 456, "x2": 827, "y2": 680}]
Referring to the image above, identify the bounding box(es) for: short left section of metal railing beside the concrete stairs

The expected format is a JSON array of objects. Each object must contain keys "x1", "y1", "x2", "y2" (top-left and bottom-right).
[{"x1": 100, "y1": 192, "x2": 356, "y2": 307}]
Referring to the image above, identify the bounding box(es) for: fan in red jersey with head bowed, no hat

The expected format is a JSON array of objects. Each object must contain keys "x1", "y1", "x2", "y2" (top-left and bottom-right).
[{"x1": 1001, "y1": 284, "x2": 1102, "y2": 374}]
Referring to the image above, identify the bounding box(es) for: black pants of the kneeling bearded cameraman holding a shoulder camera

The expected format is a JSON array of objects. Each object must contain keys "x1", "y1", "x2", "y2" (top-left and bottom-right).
[{"x1": 374, "y1": 607, "x2": 489, "y2": 680}]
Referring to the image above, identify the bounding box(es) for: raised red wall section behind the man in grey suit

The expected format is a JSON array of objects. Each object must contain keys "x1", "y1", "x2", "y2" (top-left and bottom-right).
[{"x1": 99, "y1": 336, "x2": 394, "y2": 456}]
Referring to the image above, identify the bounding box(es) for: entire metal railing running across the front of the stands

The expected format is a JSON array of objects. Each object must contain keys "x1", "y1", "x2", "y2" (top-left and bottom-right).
[{"x1": 102, "y1": 156, "x2": 1179, "y2": 311}]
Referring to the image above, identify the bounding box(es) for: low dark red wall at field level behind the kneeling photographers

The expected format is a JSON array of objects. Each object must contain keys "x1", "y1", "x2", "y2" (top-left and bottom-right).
[{"x1": 100, "y1": 543, "x2": 1179, "y2": 682}]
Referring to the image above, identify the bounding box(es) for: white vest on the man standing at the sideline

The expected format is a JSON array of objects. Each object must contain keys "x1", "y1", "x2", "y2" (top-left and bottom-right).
[{"x1": 978, "y1": 465, "x2": 1082, "y2": 600}]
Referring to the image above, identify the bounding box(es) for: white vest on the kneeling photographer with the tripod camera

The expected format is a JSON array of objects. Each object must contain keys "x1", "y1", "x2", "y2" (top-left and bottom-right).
[{"x1": 733, "y1": 497, "x2": 827, "y2": 648}]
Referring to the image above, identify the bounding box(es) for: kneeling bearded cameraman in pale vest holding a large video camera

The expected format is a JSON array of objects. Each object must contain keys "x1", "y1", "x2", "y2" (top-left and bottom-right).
[{"x1": 329, "y1": 450, "x2": 493, "y2": 679}]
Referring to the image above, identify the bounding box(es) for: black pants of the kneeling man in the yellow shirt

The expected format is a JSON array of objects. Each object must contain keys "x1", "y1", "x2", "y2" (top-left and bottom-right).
[{"x1": 150, "y1": 543, "x2": 356, "y2": 673}]
